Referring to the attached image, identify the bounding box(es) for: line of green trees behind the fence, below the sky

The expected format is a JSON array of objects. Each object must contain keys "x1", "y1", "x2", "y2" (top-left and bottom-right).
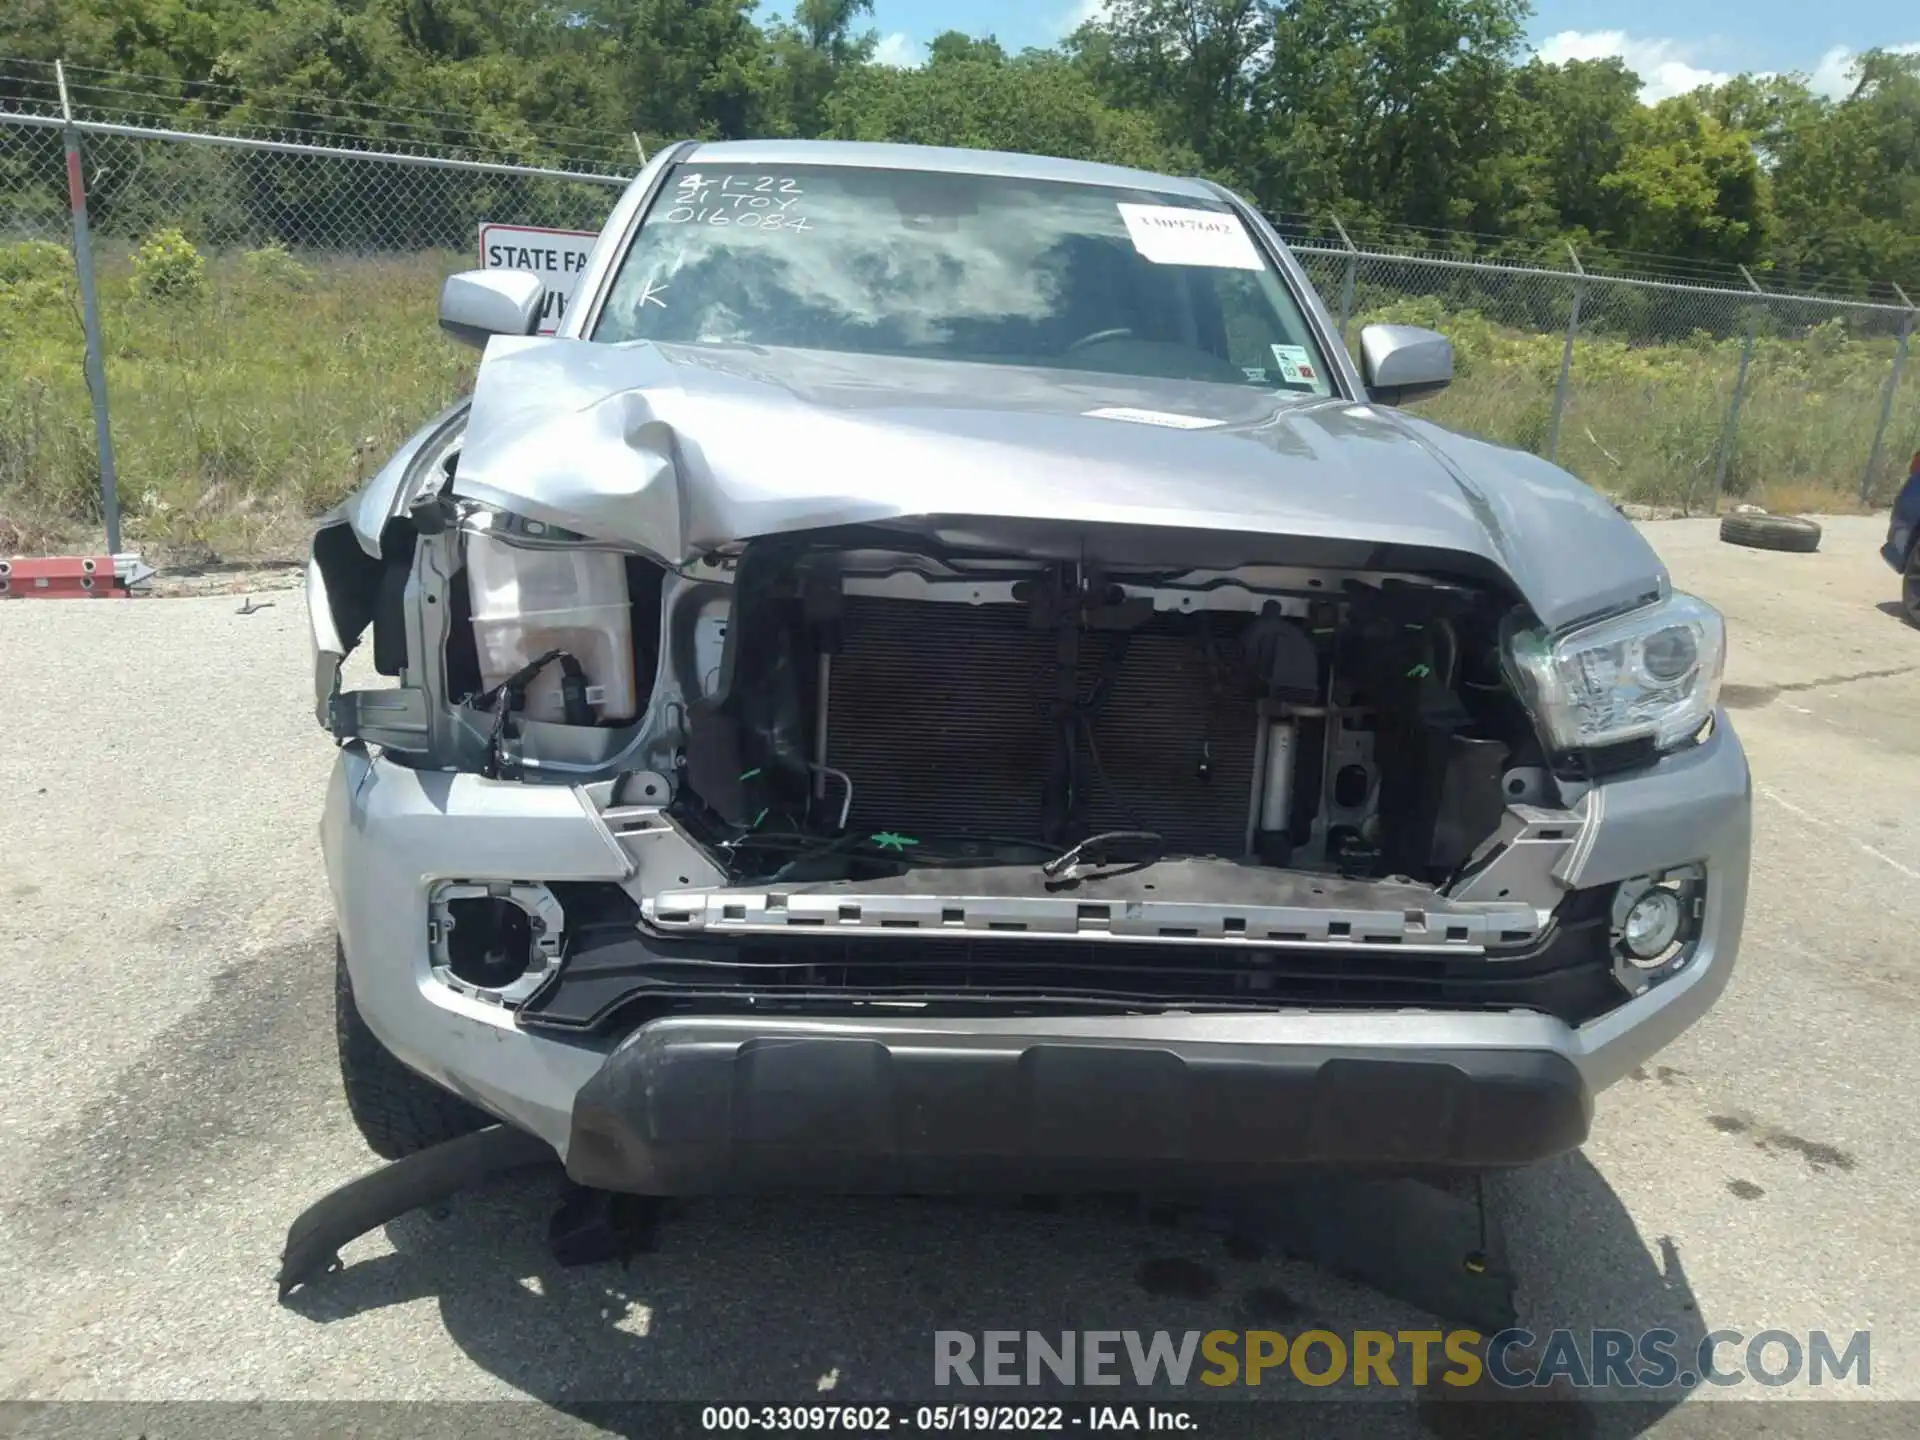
[{"x1": 0, "y1": 0, "x2": 1920, "y2": 288}]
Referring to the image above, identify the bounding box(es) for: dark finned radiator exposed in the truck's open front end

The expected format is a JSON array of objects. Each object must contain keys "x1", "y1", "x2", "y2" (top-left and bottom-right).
[{"x1": 828, "y1": 595, "x2": 1256, "y2": 854}]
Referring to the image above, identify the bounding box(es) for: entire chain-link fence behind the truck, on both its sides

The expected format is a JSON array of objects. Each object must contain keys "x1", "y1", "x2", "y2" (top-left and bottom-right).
[{"x1": 0, "y1": 96, "x2": 1920, "y2": 551}]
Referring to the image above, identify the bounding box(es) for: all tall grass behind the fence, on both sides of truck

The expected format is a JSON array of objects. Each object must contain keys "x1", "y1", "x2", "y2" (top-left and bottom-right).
[{"x1": 0, "y1": 242, "x2": 1920, "y2": 557}]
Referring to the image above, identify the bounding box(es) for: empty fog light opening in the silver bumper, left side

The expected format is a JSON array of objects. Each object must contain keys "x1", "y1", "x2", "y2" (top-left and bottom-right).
[{"x1": 426, "y1": 881, "x2": 566, "y2": 1006}]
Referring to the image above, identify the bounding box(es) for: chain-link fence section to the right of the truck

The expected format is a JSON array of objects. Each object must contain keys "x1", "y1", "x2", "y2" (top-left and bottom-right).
[{"x1": 1294, "y1": 242, "x2": 1920, "y2": 513}]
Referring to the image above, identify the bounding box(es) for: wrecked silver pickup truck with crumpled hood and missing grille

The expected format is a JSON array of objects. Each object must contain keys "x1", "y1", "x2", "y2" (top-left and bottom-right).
[{"x1": 309, "y1": 142, "x2": 1749, "y2": 1194}]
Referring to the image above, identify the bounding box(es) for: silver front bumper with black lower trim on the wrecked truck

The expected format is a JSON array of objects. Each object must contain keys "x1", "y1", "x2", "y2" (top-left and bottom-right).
[{"x1": 323, "y1": 714, "x2": 1751, "y2": 1192}]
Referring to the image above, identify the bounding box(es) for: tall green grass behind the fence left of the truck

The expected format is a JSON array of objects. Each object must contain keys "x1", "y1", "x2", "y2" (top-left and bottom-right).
[{"x1": 0, "y1": 242, "x2": 474, "y2": 555}]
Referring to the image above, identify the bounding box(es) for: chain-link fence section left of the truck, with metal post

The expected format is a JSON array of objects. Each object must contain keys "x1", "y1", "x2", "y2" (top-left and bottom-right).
[{"x1": 0, "y1": 104, "x2": 630, "y2": 553}]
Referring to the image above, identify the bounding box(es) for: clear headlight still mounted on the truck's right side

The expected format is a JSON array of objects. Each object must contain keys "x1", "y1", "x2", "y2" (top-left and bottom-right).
[{"x1": 1505, "y1": 593, "x2": 1726, "y2": 751}]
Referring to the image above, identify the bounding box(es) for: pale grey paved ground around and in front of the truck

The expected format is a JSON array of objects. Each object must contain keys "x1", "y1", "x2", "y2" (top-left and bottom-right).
[{"x1": 0, "y1": 518, "x2": 1920, "y2": 1428}]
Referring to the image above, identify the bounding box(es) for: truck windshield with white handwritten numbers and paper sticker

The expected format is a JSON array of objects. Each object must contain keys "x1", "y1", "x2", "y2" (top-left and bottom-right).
[{"x1": 593, "y1": 165, "x2": 1331, "y2": 396}]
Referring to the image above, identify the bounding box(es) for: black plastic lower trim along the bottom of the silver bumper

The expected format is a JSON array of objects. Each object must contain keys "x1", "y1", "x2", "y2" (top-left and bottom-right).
[{"x1": 566, "y1": 1018, "x2": 1592, "y2": 1194}]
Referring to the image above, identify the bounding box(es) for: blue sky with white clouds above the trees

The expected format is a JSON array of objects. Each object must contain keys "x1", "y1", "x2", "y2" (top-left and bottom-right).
[{"x1": 848, "y1": 0, "x2": 1920, "y2": 104}]
